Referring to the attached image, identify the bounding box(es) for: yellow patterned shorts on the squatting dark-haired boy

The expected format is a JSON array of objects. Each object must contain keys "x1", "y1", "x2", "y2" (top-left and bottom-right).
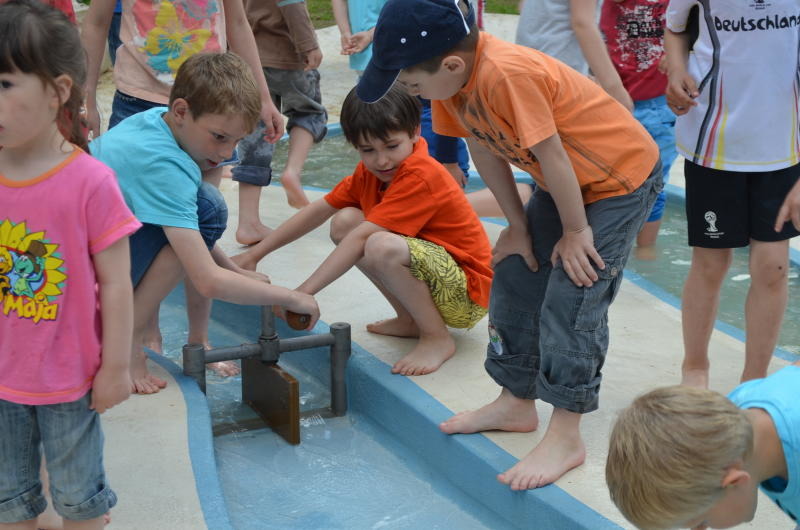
[{"x1": 403, "y1": 236, "x2": 487, "y2": 328}]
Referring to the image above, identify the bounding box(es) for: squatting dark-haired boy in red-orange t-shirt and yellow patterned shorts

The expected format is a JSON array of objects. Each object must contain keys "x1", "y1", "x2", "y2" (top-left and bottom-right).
[{"x1": 234, "y1": 89, "x2": 492, "y2": 375}]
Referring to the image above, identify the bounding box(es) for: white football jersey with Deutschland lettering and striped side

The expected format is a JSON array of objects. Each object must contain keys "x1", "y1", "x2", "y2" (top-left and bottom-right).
[{"x1": 667, "y1": 0, "x2": 800, "y2": 171}]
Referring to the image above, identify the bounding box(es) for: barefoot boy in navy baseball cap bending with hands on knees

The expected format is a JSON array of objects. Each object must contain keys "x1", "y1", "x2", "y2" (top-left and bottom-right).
[{"x1": 357, "y1": 0, "x2": 662, "y2": 490}]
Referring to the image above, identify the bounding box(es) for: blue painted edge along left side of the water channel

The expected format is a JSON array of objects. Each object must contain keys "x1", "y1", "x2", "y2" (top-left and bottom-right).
[{"x1": 148, "y1": 351, "x2": 233, "y2": 530}]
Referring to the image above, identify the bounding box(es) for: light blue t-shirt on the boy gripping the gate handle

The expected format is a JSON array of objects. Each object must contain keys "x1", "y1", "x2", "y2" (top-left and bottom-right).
[{"x1": 89, "y1": 107, "x2": 201, "y2": 230}]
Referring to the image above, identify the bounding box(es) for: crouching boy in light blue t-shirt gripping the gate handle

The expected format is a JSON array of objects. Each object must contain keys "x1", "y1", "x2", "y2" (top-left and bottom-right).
[{"x1": 90, "y1": 53, "x2": 319, "y2": 394}]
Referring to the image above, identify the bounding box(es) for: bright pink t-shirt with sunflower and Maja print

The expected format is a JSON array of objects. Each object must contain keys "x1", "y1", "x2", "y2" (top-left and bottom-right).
[{"x1": 0, "y1": 148, "x2": 141, "y2": 405}]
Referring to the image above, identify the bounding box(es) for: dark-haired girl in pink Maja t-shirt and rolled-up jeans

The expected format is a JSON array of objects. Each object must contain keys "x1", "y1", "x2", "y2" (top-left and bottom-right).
[{"x1": 0, "y1": 0, "x2": 140, "y2": 529}]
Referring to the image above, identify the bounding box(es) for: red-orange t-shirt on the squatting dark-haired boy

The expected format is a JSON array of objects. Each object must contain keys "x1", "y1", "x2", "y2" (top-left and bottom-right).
[{"x1": 325, "y1": 138, "x2": 492, "y2": 307}]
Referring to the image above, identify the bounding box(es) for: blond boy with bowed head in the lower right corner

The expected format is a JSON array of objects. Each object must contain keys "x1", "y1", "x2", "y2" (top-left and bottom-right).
[{"x1": 606, "y1": 361, "x2": 800, "y2": 529}]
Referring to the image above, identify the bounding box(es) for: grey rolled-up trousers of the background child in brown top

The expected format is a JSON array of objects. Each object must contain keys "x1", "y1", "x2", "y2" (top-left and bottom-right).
[{"x1": 233, "y1": 67, "x2": 328, "y2": 186}]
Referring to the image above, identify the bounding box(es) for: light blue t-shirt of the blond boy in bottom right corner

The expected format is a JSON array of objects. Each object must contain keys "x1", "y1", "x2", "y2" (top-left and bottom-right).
[{"x1": 728, "y1": 365, "x2": 800, "y2": 522}]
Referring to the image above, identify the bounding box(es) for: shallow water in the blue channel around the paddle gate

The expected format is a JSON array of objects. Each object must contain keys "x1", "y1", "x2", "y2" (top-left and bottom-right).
[{"x1": 161, "y1": 290, "x2": 511, "y2": 530}]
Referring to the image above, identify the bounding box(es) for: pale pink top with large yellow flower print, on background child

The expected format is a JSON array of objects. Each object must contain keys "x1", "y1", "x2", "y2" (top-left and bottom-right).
[{"x1": 114, "y1": 0, "x2": 228, "y2": 104}]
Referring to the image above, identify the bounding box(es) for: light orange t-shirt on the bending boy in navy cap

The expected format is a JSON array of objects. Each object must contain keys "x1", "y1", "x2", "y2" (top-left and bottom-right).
[{"x1": 431, "y1": 33, "x2": 658, "y2": 204}]
